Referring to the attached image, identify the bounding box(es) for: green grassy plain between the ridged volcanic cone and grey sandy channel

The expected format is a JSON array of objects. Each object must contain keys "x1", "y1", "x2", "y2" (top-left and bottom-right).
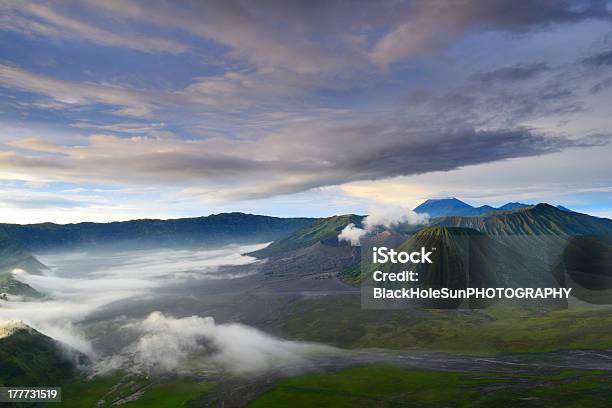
[{"x1": 282, "y1": 296, "x2": 612, "y2": 355}]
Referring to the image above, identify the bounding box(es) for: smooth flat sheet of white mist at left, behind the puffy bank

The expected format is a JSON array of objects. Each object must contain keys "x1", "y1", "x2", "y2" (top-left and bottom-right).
[{"x1": 0, "y1": 244, "x2": 267, "y2": 357}]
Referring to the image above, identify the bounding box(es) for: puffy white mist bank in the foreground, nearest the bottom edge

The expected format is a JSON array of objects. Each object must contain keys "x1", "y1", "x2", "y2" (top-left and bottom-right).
[{"x1": 96, "y1": 311, "x2": 341, "y2": 374}]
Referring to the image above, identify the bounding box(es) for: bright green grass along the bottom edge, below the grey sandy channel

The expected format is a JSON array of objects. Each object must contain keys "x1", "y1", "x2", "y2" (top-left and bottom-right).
[{"x1": 249, "y1": 365, "x2": 612, "y2": 408}]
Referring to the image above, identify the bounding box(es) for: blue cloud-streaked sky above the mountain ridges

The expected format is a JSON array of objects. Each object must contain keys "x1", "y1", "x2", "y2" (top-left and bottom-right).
[{"x1": 0, "y1": 0, "x2": 612, "y2": 224}]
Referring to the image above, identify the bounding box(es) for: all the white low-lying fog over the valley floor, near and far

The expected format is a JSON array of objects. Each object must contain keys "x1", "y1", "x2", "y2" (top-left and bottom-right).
[{"x1": 0, "y1": 244, "x2": 338, "y2": 372}]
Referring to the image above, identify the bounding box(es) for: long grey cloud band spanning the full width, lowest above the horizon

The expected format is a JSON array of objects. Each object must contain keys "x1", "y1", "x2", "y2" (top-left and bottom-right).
[{"x1": 0, "y1": 124, "x2": 606, "y2": 200}]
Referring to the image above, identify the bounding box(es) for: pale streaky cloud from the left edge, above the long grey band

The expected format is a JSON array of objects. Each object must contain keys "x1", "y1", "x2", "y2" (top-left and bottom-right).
[{"x1": 0, "y1": 63, "x2": 322, "y2": 118}]
